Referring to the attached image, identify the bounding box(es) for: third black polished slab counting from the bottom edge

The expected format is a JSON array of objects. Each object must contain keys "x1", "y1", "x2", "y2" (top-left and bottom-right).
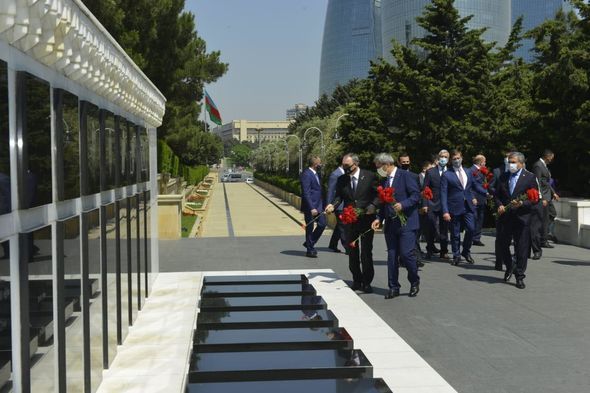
[{"x1": 193, "y1": 328, "x2": 353, "y2": 353}]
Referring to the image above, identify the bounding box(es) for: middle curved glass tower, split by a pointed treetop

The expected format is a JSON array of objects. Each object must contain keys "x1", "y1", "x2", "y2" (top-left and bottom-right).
[{"x1": 382, "y1": 0, "x2": 512, "y2": 61}]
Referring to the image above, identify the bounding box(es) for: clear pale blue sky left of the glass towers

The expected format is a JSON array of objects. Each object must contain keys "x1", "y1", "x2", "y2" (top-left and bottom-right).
[{"x1": 185, "y1": 0, "x2": 327, "y2": 123}]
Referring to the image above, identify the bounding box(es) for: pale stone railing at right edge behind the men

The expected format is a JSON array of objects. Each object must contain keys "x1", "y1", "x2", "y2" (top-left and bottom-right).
[{"x1": 553, "y1": 198, "x2": 590, "y2": 248}]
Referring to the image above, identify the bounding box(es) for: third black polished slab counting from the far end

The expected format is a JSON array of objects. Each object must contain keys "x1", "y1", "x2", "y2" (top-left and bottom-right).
[{"x1": 199, "y1": 296, "x2": 327, "y2": 311}]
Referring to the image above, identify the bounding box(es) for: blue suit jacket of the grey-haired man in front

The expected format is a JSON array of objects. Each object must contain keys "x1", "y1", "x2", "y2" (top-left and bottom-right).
[{"x1": 378, "y1": 168, "x2": 420, "y2": 231}]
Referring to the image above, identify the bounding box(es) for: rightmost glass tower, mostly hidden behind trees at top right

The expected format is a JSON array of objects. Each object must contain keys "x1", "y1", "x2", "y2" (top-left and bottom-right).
[{"x1": 512, "y1": 0, "x2": 572, "y2": 61}]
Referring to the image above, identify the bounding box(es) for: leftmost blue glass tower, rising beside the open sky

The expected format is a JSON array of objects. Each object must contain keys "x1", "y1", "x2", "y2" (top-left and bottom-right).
[{"x1": 320, "y1": 0, "x2": 382, "y2": 95}]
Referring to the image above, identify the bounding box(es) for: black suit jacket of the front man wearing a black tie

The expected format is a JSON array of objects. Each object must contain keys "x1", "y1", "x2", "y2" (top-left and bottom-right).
[{"x1": 331, "y1": 169, "x2": 379, "y2": 213}]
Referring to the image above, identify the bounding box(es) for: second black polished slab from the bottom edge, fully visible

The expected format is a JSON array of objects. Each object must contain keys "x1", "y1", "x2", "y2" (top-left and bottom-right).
[{"x1": 189, "y1": 350, "x2": 373, "y2": 383}]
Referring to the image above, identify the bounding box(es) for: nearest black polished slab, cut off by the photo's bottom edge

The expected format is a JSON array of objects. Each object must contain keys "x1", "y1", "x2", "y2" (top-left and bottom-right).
[{"x1": 186, "y1": 378, "x2": 392, "y2": 393}]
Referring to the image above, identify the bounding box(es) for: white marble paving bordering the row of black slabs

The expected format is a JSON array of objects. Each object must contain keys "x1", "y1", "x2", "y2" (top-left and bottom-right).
[{"x1": 99, "y1": 269, "x2": 456, "y2": 393}]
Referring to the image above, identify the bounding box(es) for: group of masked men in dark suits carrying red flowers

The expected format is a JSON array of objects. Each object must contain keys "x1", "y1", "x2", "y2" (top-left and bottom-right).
[{"x1": 300, "y1": 150, "x2": 559, "y2": 299}]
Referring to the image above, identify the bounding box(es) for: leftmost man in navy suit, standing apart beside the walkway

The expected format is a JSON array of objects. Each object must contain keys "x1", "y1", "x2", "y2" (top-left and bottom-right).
[{"x1": 299, "y1": 156, "x2": 326, "y2": 258}]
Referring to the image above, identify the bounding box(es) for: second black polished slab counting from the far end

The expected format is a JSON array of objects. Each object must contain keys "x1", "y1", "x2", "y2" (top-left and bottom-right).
[{"x1": 201, "y1": 284, "x2": 316, "y2": 298}]
